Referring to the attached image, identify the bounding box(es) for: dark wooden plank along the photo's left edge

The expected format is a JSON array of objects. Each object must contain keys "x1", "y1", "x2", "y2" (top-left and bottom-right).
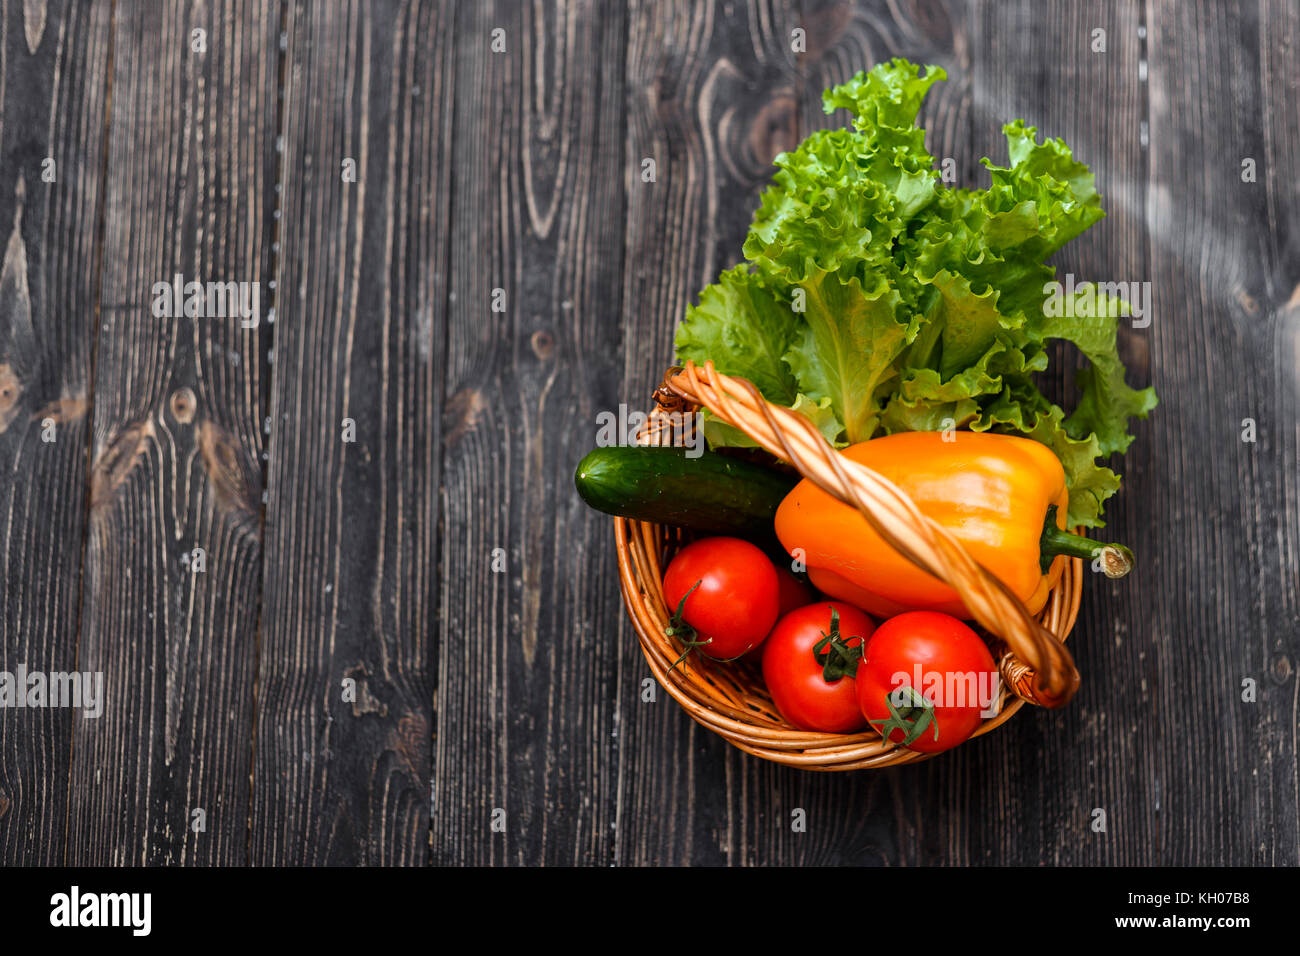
[{"x1": 0, "y1": 0, "x2": 109, "y2": 865}]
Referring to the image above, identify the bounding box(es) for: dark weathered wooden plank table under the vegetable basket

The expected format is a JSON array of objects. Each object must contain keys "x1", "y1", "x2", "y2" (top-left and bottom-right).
[{"x1": 0, "y1": 0, "x2": 1300, "y2": 865}]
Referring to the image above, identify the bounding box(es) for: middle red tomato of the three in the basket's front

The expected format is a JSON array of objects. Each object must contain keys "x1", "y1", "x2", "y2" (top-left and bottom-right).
[{"x1": 763, "y1": 602, "x2": 876, "y2": 734}]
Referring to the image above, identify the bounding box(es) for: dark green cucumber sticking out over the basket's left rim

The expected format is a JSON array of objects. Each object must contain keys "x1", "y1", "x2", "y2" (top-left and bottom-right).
[{"x1": 573, "y1": 446, "x2": 798, "y2": 542}]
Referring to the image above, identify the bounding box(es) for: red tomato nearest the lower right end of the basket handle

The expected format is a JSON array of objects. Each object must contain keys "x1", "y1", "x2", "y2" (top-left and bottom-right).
[{"x1": 858, "y1": 611, "x2": 998, "y2": 753}]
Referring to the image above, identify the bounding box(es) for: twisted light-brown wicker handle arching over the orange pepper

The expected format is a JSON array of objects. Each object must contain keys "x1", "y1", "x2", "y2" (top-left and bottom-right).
[{"x1": 655, "y1": 362, "x2": 1079, "y2": 708}]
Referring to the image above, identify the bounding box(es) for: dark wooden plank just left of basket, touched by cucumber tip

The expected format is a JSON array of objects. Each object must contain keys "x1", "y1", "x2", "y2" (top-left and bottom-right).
[{"x1": 433, "y1": 0, "x2": 629, "y2": 864}]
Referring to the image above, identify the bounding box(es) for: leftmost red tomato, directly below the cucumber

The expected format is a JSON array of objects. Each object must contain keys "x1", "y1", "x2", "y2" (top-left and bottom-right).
[{"x1": 663, "y1": 537, "x2": 780, "y2": 661}]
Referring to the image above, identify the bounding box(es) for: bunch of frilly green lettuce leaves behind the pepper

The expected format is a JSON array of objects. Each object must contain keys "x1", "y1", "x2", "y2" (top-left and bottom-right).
[{"x1": 676, "y1": 60, "x2": 1156, "y2": 528}]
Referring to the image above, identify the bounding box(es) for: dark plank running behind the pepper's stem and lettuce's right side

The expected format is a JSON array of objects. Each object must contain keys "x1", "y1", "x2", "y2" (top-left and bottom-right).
[{"x1": 949, "y1": 3, "x2": 1154, "y2": 865}]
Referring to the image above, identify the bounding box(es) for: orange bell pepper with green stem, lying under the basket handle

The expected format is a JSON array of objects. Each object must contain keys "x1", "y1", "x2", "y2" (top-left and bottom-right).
[{"x1": 776, "y1": 432, "x2": 1132, "y2": 619}]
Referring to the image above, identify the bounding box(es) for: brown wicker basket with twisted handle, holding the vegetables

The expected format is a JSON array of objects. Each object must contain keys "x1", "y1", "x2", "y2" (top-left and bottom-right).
[{"x1": 615, "y1": 363, "x2": 1083, "y2": 770}]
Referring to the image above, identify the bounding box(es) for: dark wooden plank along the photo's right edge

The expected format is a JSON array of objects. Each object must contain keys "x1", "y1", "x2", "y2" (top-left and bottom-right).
[{"x1": 1128, "y1": 3, "x2": 1300, "y2": 866}]
